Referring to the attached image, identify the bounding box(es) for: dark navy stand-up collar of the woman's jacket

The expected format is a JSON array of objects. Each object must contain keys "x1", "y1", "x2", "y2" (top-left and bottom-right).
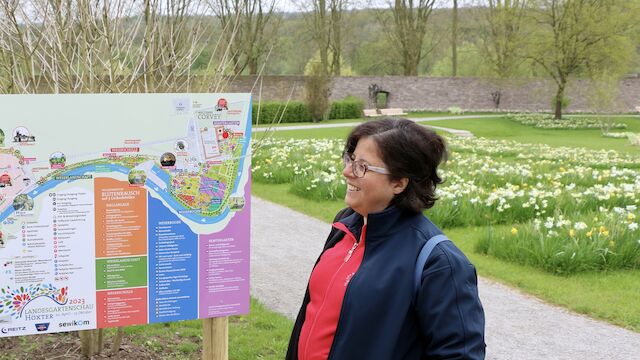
[{"x1": 339, "y1": 205, "x2": 404, "y2": 241}]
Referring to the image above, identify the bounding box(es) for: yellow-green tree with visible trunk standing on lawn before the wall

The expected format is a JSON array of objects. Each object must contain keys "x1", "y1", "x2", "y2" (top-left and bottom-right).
[{"x1": 529, "y1": 0, "x2": 635, "y2": 119}]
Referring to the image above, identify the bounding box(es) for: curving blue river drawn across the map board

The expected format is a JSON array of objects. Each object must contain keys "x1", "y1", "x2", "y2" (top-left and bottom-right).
[{"x1": 0, "y1": 111, "x2": 251, "y2": 224}]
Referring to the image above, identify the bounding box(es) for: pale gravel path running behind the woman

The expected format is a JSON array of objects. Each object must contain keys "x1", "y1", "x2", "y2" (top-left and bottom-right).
[{"x1": 251, "y1": 197, "x2": 640, "y2": 360}]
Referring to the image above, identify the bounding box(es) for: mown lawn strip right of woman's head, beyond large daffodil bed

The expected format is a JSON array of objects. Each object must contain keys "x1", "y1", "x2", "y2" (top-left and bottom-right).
[{"x1": 423, "y1": 117, "x2": 640, "y2": 153}]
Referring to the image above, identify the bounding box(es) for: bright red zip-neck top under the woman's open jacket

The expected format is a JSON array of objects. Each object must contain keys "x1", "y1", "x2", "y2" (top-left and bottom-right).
[{"x1": 298, "y1": 222, "x2": 367, "y2": 360}]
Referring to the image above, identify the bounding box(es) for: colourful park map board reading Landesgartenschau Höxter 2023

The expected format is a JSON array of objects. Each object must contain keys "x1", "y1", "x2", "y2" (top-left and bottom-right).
[{"x1": 0, "y1": 94, "x2": 251, "y2": 337}]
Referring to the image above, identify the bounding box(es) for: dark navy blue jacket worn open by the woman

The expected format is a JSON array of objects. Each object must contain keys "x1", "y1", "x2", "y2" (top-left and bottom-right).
[{"x1": 286, "y1": 207, "x2": 485, "y2": 360}]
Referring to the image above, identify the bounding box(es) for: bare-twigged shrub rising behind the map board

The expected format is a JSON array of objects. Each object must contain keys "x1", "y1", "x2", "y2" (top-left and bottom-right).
[{"x1": 0, "y1": 0, "x2": 242, "y2": 357}]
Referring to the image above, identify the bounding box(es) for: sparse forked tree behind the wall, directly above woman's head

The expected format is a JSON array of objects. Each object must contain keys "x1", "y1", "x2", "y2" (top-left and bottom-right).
[{"x1": 382, "y1": 0, "x2": 436, "y2": 76}]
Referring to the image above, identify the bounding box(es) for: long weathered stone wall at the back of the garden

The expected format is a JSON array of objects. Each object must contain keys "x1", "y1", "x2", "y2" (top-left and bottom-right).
[{"x1": 228, "y1": 76, "x2": 640, "y2": 112}]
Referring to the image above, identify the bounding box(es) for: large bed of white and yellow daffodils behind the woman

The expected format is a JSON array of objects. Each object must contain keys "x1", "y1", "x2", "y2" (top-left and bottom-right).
[{"x1": 253, "y1": 138, "x2": 640, "y2": 274}]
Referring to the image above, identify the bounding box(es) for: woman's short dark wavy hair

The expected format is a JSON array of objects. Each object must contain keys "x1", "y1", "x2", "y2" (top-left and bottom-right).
[{"x1": 344, "y1": 118, "x2": 447, "y2": 212}]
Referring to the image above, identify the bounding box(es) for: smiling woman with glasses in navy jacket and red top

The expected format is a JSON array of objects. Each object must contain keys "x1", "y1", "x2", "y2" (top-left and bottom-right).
[{"x1": 287, "y1": 119, "x2": 485, "y2": 360}]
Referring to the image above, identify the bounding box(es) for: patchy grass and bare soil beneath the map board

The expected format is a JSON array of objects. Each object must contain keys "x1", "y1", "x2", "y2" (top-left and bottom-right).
[{"x1": 0, "y1": 299, "x2": 293, "y2": 360}]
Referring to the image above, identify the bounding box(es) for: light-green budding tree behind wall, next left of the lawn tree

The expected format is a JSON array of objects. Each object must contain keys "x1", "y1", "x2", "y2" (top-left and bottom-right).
[{"x1": 480, "y1": 0, "x2": 529, "y2": 79}]
